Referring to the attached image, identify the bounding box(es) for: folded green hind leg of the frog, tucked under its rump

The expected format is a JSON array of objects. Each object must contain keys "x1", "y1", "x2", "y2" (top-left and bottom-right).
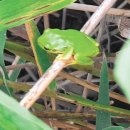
[{"x1": 74, "y1": 54, "x2": 94, "y2": 65}]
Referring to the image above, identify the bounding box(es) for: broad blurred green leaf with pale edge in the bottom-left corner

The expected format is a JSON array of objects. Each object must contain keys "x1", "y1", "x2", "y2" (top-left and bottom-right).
[{"x1": 0, "y1": 91, "x2": 52, "y2": 130}]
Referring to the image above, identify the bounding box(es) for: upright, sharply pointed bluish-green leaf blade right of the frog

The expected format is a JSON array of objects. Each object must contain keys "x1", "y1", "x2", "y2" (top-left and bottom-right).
[{"x1": 96, "y1": 54, "x2": 111, "y2": 130}]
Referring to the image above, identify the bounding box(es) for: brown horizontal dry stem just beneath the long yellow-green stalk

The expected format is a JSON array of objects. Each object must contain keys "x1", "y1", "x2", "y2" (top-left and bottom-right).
[{"x1": 33, "y1": 111, "x2": 130, "y2": 124}]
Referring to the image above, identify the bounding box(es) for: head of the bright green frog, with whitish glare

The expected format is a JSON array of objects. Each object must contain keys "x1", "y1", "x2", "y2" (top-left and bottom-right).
[{"x1": 38, "y1": 29, "x2": 68, "y2": 54}]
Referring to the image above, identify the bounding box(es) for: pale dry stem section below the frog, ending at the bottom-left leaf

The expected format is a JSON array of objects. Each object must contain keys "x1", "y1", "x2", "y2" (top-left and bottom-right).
[{"x1": 20, "y1": 60, "x2": 67, "y2": 109}]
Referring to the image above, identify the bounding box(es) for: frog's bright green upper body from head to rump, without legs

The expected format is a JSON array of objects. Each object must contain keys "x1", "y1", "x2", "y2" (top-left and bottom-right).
[{"x1": 41, "y1": 29, "x2": 98, "y2": 56}]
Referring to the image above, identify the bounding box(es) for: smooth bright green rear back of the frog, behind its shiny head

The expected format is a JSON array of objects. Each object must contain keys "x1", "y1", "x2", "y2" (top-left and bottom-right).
[{"x1": 63, "y1": 29, "x2": 98, "y2": 56}]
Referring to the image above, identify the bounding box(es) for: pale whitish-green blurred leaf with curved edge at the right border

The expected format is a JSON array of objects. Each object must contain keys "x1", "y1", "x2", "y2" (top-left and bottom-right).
[{"x1": 114, "y1": 40, "x2": 130, "y2": 101}]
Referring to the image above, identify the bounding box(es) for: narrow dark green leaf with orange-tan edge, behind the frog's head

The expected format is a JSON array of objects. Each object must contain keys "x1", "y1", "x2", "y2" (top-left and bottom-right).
[{"x1": 26, "y1": 20, "x2": 56, "y2": 90}]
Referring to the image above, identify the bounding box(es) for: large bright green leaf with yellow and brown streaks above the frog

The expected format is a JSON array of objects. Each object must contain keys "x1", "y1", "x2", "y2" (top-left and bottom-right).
[{"x1": 0, "y1": 0, "x2": 75, "y2": 30}]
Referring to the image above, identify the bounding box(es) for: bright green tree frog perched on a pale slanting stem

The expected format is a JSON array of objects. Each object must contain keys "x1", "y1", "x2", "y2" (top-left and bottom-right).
[{"x1": 38, "y1": 28, "x2": 99, "y2": 65}]
